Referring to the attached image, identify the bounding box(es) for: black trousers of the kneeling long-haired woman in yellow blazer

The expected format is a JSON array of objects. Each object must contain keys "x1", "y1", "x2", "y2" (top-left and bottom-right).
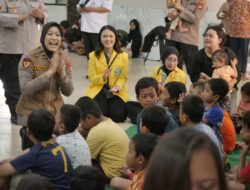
[{"x1": 94, "y1": 90, "x2": 127, "y2": 122}]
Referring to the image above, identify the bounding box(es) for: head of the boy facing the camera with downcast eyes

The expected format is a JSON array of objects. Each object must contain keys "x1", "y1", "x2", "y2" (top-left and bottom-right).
[{"x1": 135, "y1": 77, "x2": 159, "y2": 108}]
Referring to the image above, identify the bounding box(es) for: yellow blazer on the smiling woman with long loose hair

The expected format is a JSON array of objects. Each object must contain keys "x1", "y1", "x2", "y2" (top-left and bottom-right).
[{"x1": 86, "y1": 51, "x2": 128, "y2": 102}]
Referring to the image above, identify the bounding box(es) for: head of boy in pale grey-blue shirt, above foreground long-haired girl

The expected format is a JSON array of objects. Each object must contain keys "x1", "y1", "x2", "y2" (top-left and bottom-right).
[{"x1": 180, "y1": 95, "x2": 205, "y2": 125}]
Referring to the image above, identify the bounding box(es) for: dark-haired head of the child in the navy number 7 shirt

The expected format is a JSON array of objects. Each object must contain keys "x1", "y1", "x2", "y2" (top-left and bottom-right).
[{"x1": 27, "y1": 109, "x2": 55, "y2": 143}]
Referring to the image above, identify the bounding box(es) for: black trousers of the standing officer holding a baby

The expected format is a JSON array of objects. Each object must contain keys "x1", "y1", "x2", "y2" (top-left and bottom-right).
[{"x1": 166, "y1": 40, "x2": 198, "y2": 79}]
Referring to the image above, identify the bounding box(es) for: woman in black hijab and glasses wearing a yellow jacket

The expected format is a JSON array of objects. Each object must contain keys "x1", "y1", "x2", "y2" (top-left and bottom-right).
[{"x1": 153, "y1": 46, "x2": 187, "y2": 90}]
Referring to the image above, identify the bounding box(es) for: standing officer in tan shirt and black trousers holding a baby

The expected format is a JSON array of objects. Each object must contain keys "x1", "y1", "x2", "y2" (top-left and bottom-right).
[{"x1": 166, "y1": 0, "x2": 207, "y2": 80}]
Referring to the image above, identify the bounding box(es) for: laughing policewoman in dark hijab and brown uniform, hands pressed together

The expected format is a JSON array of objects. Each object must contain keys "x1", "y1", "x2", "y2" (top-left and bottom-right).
[{"x1": 16, "y1": 22, "x2": 73, "y2": 148}]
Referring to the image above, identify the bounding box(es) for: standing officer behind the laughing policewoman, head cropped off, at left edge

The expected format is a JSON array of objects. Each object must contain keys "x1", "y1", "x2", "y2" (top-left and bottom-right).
[{"x1": 0, "y1": 0, "x2": 46, "y2": 124}]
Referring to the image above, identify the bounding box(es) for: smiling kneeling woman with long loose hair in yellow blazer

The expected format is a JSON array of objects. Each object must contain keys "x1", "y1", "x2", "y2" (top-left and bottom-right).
[{"x1": 86, "y1": 25, "x2": 128, "y2": 122}]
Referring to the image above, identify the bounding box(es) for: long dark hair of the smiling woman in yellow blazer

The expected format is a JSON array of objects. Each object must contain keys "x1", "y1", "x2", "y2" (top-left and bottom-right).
[{"x1": 95, "y1": 25, "x2": 122, "y2": 57}]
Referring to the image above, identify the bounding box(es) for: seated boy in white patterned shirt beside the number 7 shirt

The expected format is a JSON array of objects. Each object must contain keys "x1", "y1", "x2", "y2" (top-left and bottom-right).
[{"x1": 54, "y1": 104, "x2": 91, "y2": 168}]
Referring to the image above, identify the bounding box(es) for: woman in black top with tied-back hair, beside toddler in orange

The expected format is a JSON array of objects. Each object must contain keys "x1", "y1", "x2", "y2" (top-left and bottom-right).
[{"x1": 191, "y1": 25, "x2": 225, "y2": 82}]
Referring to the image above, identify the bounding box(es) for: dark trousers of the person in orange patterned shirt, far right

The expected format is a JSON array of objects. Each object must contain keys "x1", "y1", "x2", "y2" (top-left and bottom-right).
[{"x1": 230, "y1": 37, "x2": 250, "y2": 75}]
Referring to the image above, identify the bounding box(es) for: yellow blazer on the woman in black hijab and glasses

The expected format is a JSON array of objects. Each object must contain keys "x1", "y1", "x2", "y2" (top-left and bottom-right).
[{"x1": 153, "y1": 66, "x2": 187, "y2": 85}]
